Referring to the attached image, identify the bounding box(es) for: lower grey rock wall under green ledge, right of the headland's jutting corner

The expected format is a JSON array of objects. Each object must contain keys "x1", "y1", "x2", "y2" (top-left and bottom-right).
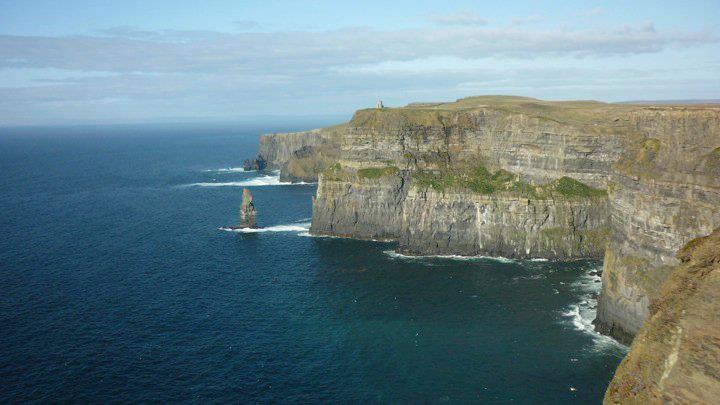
[{"x1": 398, "y1": 187, "x2": 607, "y2": 259}]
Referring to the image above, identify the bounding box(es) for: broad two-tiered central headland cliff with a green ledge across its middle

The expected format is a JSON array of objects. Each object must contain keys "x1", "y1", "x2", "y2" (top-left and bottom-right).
[{"x1": 311, "y1": 97, "x2": 622, "y2": 259}]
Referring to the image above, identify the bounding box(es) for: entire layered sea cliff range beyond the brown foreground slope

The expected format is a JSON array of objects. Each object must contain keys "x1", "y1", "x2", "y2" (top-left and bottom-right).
[{"x1": 252, "y1": 96, "x2": 720, "y2": 342}]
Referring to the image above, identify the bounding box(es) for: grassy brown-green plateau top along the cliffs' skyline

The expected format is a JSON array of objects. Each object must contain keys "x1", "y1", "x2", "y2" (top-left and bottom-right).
[{"x1": 350, "y1": 96, "x2": 720, "y2": 130}]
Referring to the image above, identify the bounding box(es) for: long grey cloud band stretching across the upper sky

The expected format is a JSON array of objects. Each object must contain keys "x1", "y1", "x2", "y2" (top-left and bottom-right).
[{"x1": 0, "y1": 23, "x2": 717, "y2": 75}]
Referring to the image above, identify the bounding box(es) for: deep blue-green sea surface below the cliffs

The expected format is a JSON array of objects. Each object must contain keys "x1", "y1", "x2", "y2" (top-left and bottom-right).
[{"x1": 0, "y1": 123, "x2": 626, "y2": 403}]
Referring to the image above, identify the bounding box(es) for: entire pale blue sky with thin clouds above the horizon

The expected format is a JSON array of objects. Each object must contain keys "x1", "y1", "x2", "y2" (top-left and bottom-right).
[{"x1": 0, "y1": 0, "x2": 720, "y2": 125}]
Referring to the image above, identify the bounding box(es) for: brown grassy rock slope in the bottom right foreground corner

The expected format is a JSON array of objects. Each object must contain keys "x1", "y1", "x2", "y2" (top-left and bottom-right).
[{"x1": 605, "y1": 229, "x2": 720, "y2": 404}]
